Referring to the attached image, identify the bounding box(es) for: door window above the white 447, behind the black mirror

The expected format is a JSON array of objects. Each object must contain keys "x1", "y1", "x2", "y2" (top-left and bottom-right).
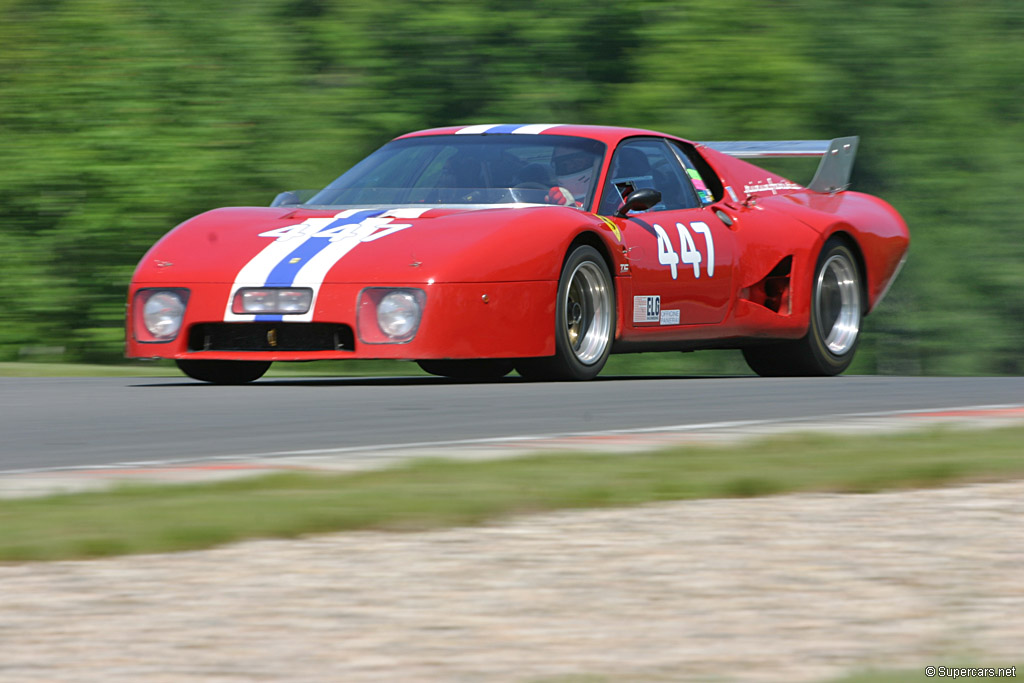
[{"x1": 598, "y1": 137, "x2": 700, "y2": 214}]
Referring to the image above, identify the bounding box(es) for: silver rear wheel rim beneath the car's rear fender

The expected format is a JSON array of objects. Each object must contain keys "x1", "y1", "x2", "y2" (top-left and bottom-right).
[{"x1": 814, "y1": 253, "x2": 861, "y2": 356}]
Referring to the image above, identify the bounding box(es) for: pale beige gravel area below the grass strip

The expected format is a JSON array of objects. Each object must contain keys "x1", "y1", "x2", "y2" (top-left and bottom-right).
[{"x1": 0, "y1": 481, "x2": 1024, "y2": 682}]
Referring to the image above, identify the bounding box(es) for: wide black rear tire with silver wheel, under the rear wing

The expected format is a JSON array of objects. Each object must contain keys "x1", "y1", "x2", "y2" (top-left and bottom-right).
[{"x1": 743, "y1": 238, "x2": 864, "y2": 377}]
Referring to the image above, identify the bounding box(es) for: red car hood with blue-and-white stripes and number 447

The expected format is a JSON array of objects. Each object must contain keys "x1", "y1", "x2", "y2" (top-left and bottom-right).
[{"x1": 133, "y1": 205, "x2": 600, "y2": 286}]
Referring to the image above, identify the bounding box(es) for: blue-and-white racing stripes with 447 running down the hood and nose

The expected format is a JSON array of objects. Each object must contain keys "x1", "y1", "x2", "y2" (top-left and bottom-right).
[{"x1": 224, "y1": 208, "x2": 429, "y2": 323}]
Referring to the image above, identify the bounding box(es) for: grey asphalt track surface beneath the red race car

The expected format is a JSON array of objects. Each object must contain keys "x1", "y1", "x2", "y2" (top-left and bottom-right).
[{"x1": 0, "y1": 376, "x2": 1024, "y2": 472}]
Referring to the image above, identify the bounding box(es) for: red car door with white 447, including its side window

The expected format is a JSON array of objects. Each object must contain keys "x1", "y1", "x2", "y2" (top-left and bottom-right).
[{"x1": 598, "y1": 137, "x2": 734, "y2": 329}]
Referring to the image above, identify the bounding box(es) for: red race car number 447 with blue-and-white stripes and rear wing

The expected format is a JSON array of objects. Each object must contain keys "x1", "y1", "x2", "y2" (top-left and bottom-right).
[{"x1": 127, "y1": 124, "x2": 909, "y2": 384}]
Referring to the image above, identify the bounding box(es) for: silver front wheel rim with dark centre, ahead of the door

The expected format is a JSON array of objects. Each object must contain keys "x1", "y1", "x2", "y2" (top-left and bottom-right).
[{"x1": 563, "y1": 261, "x2": 611, "y2": 366}]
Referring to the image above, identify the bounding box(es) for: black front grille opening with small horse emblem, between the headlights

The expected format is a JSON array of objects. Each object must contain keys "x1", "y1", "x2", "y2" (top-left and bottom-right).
[{"x1": 188, "y1": 323, "x2": 355, "y2": 351}]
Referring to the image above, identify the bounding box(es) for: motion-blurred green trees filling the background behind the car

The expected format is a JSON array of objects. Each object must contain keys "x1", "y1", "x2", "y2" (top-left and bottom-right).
[{"x1": 0, "y1": 0, "x2": 1024, "y2": 374}]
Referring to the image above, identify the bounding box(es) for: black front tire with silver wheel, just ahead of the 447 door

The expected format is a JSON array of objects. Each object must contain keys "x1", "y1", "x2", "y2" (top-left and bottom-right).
[{"x1": 515, "y1": 245, "x2": 615, "y2": 380}]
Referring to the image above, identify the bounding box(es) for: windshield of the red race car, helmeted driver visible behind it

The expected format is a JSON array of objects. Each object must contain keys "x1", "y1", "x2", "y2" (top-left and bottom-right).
[{"x1": 306, "y1": 135, "x2": 605, "y2": 209}]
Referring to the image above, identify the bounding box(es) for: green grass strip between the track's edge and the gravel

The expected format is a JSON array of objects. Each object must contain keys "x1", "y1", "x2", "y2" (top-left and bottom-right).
[{"x1": 0, "y1": 427, "x2": 1024, "y2": 561}]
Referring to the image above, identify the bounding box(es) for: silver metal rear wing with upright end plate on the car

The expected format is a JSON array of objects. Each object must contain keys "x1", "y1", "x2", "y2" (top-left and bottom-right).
[{"x1": 701, "y1": 135, "x2": 860, "y2": 194}]
